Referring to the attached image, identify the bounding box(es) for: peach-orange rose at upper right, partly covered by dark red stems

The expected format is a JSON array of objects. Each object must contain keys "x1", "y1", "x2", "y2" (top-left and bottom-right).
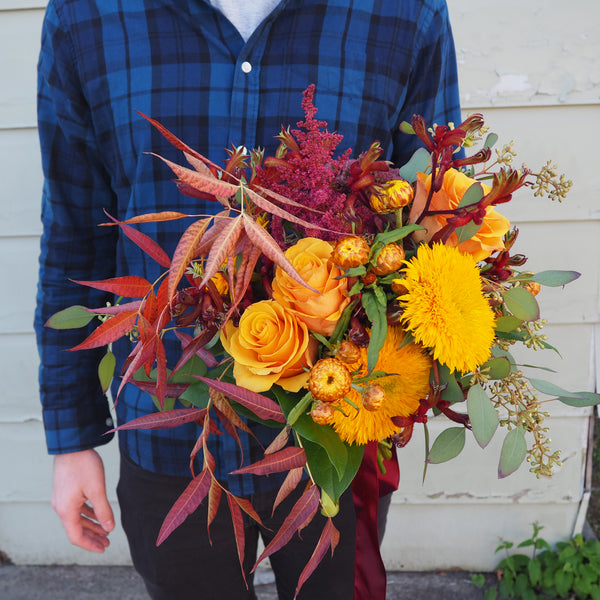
[{"x1": 409, "y1": 169, "x2": 510, "y2": 262}]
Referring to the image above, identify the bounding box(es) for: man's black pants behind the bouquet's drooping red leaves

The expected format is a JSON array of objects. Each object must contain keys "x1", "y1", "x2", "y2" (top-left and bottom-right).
[{"x1": 117, "y1": 457, "x2": 356, "y2": 600}]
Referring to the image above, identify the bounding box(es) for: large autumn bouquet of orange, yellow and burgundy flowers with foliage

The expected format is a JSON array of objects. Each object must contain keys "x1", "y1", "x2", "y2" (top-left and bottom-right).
[{"x1": 48, "y1": 86, "x2": 599, "y2": 589}]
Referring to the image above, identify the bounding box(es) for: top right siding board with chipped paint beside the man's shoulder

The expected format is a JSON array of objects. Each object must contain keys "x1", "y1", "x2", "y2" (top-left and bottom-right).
[{"x1": 448, "y1": 0, "x2": 600, "y2": 107}]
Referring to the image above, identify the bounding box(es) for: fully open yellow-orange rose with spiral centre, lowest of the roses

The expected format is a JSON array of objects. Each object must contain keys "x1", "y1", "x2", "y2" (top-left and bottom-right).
[{"x1": 221, "y1": 300, "x2": 318, "y2": 392}]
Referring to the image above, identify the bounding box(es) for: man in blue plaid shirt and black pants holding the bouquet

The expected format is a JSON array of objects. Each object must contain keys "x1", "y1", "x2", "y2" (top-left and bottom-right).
[{"x1": 35, "y1": 0, "x2": 460, "y2": 600}]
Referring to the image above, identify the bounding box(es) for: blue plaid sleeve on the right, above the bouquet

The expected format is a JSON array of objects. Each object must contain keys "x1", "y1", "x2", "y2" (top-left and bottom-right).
[{"x1": 392, "y1": 0, "x2": 462, "y2": 165}]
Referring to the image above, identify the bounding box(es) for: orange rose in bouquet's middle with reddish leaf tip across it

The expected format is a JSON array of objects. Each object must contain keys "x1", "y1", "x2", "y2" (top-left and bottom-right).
[{"x1": 273, "y1": 237, "x2": 350, "y2": 336}]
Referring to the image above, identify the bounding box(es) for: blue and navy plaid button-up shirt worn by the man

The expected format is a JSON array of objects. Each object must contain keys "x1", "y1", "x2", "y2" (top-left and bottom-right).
[{"x1": 35, "y1": 0, "x2": 460, "y2": 493}]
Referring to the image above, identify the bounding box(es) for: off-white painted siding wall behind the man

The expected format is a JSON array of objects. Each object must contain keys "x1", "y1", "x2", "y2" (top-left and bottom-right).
[{"x1": 0, "y1": 0, "x2": 600, "y2": 569}]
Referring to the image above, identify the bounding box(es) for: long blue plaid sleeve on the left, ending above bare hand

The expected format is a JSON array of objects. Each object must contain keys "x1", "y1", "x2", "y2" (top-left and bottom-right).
[{"x1": 34, "y1": 2, "x2": 116, "y2": 454}]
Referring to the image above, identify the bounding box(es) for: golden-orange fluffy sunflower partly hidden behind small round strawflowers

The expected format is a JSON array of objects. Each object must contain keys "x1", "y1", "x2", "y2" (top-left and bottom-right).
[{"x1": 332, "y1": 327, "x2": 431, "y2": 444}]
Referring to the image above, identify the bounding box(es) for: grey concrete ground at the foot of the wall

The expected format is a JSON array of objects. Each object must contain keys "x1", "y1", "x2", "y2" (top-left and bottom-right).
[{"x1": 0, "y1": 565, "x2": 492, "y2": 600}]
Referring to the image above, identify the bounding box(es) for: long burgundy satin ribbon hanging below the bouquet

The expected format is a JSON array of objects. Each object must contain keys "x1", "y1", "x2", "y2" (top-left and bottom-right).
[{"x1": 352, "y1": 442, "x2": 400, "y2": 600}]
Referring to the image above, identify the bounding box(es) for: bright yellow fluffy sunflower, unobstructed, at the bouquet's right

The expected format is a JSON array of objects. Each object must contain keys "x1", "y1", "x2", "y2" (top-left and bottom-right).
[{"x1": 398, "y1": 244, "x2": 495, "y2": 373}]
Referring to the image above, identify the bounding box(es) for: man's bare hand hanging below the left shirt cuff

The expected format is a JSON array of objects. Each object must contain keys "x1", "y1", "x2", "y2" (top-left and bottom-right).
[{"x1": 52, "y1": 450, "x2": 115, "y2": 552}]
